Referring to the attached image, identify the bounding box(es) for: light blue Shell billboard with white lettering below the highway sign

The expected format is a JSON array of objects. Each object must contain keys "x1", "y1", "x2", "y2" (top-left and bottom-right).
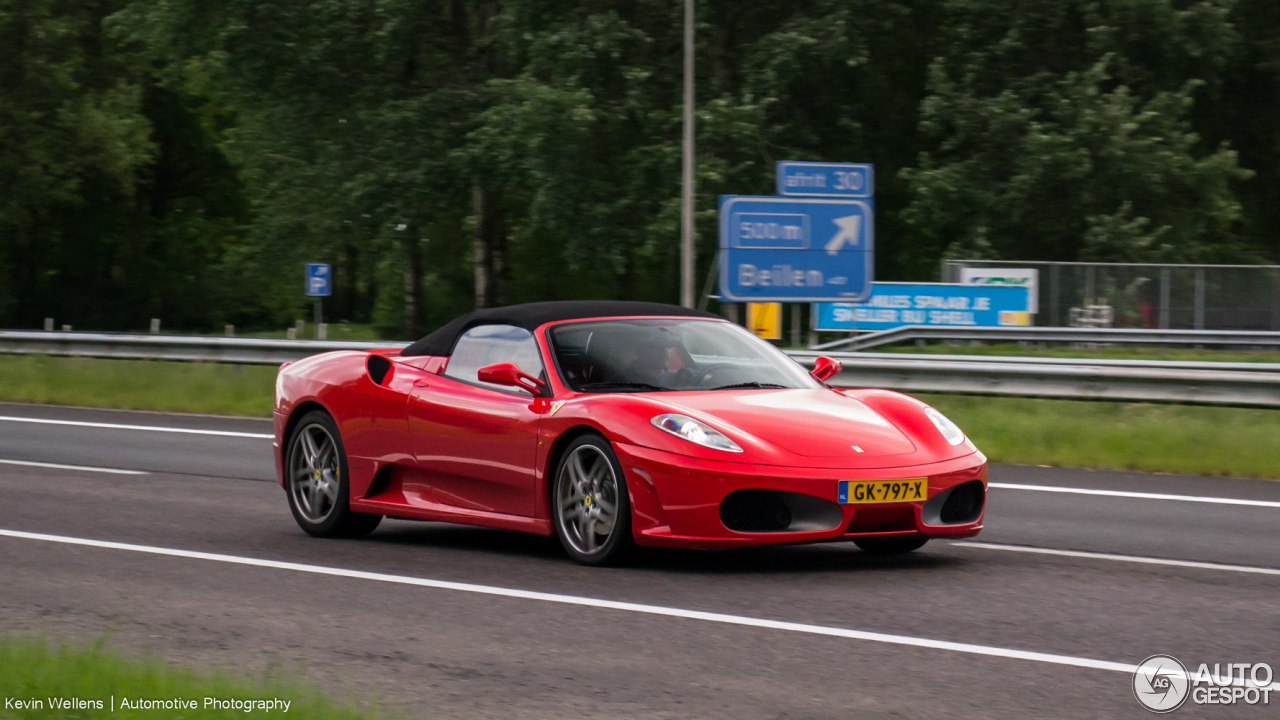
[{"x1": 817, "y1": 283, "x2": 1030, "y2": 331}]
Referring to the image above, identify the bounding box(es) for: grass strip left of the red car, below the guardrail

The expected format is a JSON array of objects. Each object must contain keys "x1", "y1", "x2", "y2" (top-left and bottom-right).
[{"x1": 0, "y1": 355, "x2": 276, "y2": 416}]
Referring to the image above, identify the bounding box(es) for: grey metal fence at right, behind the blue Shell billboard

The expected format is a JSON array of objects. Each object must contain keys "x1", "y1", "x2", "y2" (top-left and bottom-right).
[{"x1": 942, "y1": 260, "x2": 1280, "y2": 331}]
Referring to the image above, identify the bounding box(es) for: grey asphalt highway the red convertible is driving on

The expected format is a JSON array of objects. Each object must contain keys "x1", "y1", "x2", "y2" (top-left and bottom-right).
[{"x1": 0, "y1": 404, "x2": 1280, "y2": 720}]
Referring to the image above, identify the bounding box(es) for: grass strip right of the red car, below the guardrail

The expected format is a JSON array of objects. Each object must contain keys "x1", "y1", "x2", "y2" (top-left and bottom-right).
[{"x1": 919, "y1": 395, "x2": 1280, "y2": 478}]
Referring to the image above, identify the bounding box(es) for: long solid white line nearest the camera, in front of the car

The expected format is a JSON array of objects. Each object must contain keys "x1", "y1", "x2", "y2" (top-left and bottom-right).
[{"x1": 0, "y1": 529, "x2": 1167, "y2": 673}]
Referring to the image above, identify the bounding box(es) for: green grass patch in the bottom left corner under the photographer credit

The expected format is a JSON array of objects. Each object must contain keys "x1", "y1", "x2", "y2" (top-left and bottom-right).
[{"x1": 0, "y1": 638, "x2": 374, "y2": 720}]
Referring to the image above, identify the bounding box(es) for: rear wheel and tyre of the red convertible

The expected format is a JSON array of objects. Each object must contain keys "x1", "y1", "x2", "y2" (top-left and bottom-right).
[{"x1": 284, "y1": 410, "x2": 383, "y2": 538}]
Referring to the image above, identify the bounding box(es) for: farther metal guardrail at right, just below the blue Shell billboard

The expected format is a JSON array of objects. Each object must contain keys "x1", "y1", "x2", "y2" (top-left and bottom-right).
[{"x1": 810, "y1": 325, "x2": 1280, "y2": 351}]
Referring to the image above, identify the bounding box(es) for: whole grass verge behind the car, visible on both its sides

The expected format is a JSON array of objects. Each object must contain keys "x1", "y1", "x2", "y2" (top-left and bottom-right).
[{"x1": 0, "y1": 355, "x2": 1280, "y2": 478}]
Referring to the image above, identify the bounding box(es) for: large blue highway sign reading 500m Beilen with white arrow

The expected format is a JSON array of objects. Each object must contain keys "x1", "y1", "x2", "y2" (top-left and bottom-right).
[{"x1": 719, "y1": 195, "x2": 876, "y2": 302}]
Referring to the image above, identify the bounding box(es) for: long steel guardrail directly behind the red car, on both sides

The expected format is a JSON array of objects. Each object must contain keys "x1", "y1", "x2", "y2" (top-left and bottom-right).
[{"x1": 0, "y1": 331, "x2": 1280, "y2": 407}]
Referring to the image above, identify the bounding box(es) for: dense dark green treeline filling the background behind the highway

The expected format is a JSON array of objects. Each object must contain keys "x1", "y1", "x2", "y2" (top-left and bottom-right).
[{"x1": 0, "y1": 0, "x2": 1280, "y2": 336}]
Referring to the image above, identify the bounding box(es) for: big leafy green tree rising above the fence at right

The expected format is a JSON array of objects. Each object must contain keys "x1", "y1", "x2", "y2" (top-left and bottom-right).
[{"x1": 904, "y1": 0, "x2": 1251, "y2": 261}]
